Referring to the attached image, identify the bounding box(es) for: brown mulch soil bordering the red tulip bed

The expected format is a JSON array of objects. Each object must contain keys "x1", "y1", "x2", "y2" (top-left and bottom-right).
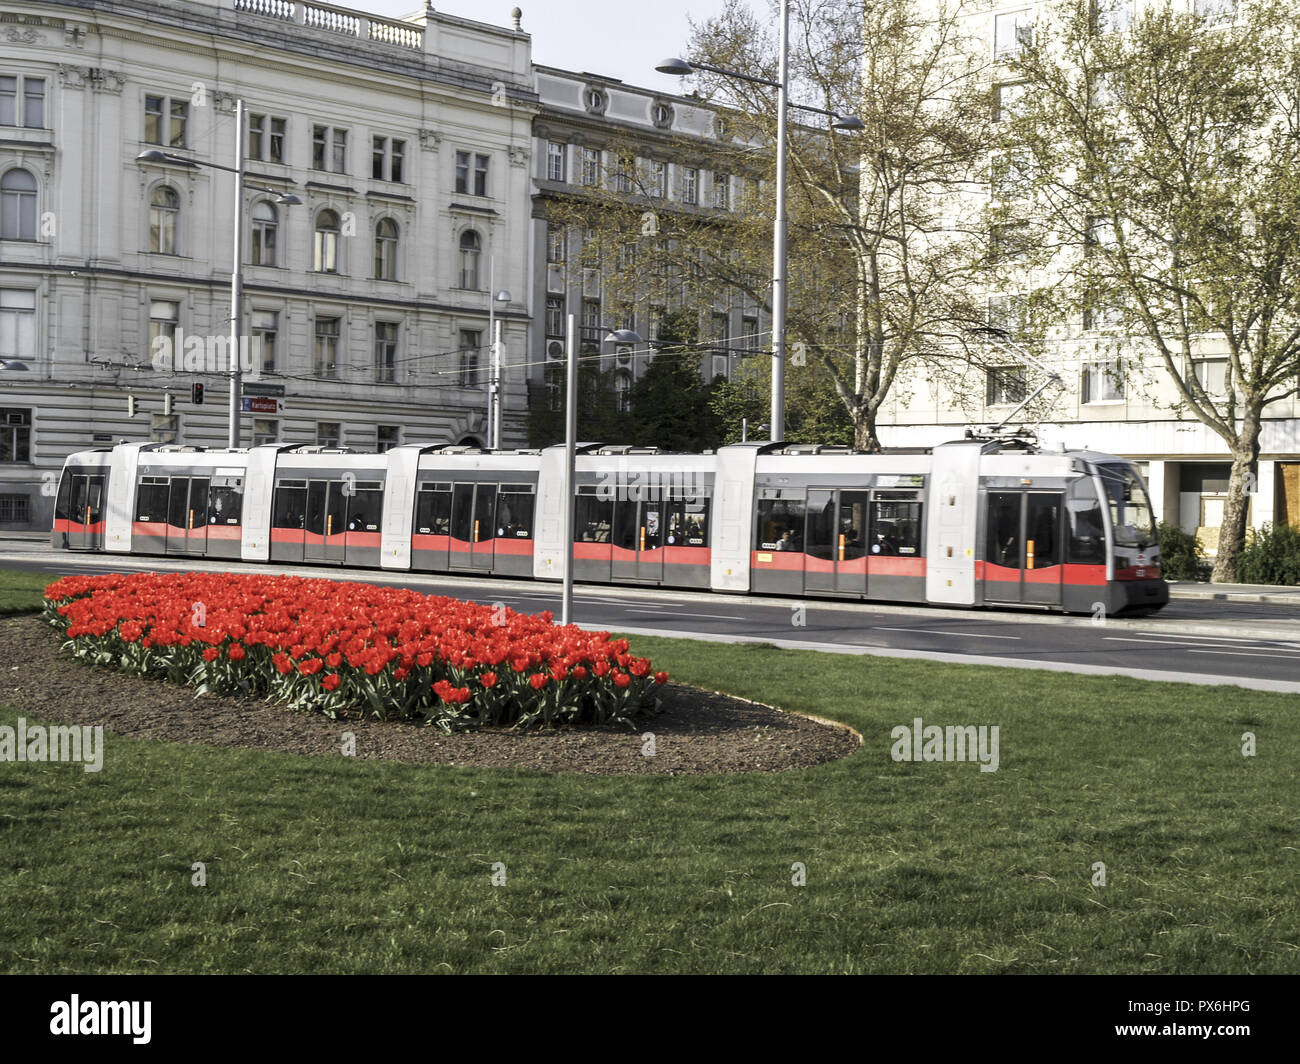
[{"x1": 0, "y1": 615, "x2": 861, "y2": 775}]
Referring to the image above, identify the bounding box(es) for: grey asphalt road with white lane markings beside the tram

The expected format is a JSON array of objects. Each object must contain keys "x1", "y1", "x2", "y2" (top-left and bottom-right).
[{"x1": 0, "y1": 544, "x2": 1300, "y2": 691}]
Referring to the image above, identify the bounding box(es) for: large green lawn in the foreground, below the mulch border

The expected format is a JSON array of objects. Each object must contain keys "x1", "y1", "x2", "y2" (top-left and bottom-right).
[{"x1": 0, "y1": 572, "x2": 1300, "y2": 973}]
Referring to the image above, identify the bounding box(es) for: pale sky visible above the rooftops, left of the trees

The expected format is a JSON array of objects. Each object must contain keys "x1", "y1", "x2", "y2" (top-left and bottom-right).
[{"x1": 361, "y1": 0, "x2": 743, "y2": 92}]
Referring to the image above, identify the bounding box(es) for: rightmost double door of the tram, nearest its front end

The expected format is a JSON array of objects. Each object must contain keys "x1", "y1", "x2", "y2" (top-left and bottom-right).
[{"x1": 984, "y1": 492, "x2": 1065, "y2": 606}]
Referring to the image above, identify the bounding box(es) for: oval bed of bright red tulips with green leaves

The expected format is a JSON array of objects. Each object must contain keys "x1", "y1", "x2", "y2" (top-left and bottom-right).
[{"x1": 46, "y1": 572, "x2": 668, "y2": 731}]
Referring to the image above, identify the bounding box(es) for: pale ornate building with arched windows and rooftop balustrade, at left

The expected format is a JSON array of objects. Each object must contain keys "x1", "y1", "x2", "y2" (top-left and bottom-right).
[{"x1": 0, "y1": 0, "x2": 537, "y2": 528}]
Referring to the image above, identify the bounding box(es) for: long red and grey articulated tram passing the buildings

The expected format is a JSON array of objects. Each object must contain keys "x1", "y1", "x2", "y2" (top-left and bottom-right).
[{"x1": 52, "y1": 437, "x2": 1169, "y2": 615}]
